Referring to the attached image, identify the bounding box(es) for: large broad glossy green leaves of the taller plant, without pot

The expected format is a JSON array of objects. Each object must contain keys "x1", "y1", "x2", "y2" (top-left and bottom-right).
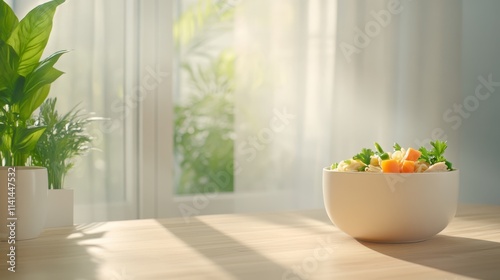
[{"x1": 0, "y1": 0, "x2": 65, "y2": 166}]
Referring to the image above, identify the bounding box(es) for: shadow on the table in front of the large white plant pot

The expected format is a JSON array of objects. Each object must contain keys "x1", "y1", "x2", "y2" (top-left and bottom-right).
[{"x1": 0, "y1": 224, "x2": 105, "y2": 280}]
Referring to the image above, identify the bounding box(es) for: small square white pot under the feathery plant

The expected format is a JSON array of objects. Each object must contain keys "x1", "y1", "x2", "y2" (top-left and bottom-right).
[{"x1": 45, "y1": 189, "x2": 73, "y2": 228}]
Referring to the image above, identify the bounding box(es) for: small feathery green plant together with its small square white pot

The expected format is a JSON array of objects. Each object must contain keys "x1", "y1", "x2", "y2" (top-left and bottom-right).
[{"x1": 32, "y1": 98, "x2": 98, "y2": 227}]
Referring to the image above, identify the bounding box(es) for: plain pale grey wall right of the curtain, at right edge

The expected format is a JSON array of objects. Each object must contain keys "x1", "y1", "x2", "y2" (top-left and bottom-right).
[{"x1": 460, "y1": 0, "x2": 500, "y2": 204}]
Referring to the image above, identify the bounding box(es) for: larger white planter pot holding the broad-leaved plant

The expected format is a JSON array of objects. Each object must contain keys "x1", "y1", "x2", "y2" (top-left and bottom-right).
[{"x1": 0, "y1": 166, "x2": 48, "y2": 241}]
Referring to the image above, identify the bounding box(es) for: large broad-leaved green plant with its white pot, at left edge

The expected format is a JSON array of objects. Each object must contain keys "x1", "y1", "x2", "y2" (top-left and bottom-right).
[{"x1": 0, "y1": 0, "x2": 65, "y2": 239}]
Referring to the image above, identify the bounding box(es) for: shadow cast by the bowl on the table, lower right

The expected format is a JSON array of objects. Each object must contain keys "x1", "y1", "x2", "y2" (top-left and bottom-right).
[{"x1": 359, "y1": 235, "x2": 500, "y2": 279}]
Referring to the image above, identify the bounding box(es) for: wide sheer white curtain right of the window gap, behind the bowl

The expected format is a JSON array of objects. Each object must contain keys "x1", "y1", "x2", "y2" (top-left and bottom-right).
[{"x1": 235, "y1": 0, "x2": 462, "y2": 211}]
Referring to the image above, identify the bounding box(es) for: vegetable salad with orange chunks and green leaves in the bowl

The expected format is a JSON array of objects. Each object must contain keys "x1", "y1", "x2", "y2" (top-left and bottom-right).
[{"x1": 331, "y1": 140, "x2": 453, "y2": 173}]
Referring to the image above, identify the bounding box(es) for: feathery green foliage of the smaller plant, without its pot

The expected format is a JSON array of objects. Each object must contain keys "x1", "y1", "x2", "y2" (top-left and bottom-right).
[{"x1": 32, "y1": 98, "x2": 94, "y2": 189}]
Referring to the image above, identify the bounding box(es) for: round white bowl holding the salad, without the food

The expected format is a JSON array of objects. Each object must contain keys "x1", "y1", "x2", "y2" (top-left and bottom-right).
[{"x1": 323, "y1": 168, "x2": 459, "y2": 243}]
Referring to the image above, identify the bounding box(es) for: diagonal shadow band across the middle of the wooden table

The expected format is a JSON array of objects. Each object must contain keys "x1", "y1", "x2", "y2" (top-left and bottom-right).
[{"x1": 162, "y1": 217, "x2": 288, "y2": 279}]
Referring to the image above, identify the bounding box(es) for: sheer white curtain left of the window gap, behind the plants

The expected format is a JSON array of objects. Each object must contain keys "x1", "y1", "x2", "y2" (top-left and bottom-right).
[{"x1": 9, "y1": 0, "x2": 141, "y2": 223}]
